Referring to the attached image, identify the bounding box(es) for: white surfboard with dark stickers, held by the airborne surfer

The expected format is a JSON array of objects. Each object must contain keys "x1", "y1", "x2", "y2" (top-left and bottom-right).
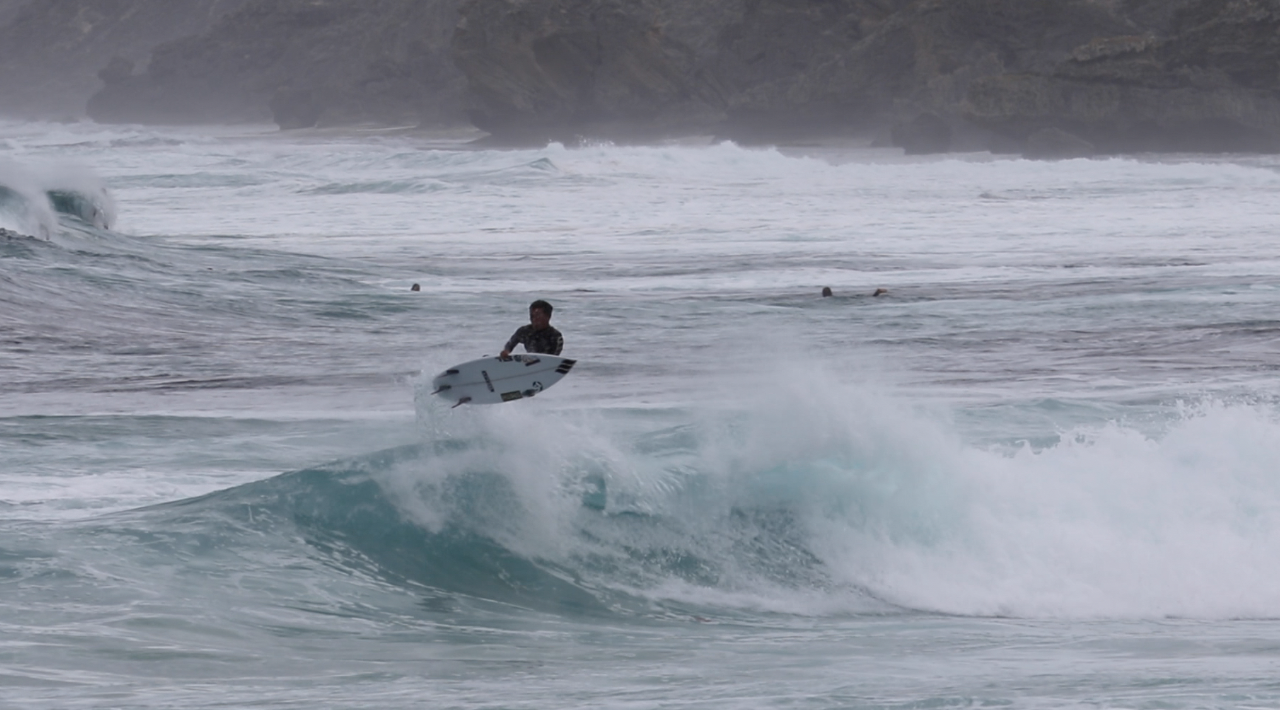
[{"x1": 431, "y1": 353, "x2": 577, "y2": 407}]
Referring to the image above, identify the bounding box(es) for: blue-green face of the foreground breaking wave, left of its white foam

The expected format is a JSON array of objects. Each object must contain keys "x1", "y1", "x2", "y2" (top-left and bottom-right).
[{"x1": 110, "y1": 432, "x2": 827, "y2": 614}]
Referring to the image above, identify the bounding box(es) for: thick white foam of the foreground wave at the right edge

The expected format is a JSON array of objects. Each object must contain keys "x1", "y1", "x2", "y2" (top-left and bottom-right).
[{"x1": 814, "y1": 396, "x2": 1280, "y2": 618}]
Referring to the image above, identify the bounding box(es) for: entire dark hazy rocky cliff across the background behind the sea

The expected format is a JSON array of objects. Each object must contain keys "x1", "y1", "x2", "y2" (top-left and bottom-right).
[{"x1": 0, "y1": 0, "x2": 1280, "y2": 156}]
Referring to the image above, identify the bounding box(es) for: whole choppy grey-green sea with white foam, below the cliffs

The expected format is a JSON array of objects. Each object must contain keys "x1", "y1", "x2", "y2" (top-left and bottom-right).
[{"x1": 0, "y1": 123, "x2": 1280, "y2": 709}]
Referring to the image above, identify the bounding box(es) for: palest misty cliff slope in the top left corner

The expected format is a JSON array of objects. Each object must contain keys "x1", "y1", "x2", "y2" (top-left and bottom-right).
[{"x1": 0, "y1": 0, "x2": 246, "y2": 118}]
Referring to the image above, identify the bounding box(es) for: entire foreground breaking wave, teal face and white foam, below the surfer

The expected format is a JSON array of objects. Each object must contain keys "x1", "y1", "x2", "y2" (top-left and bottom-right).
[{"x1": 104, "y1": 393, "x2": 1280, "y2": 618}]
